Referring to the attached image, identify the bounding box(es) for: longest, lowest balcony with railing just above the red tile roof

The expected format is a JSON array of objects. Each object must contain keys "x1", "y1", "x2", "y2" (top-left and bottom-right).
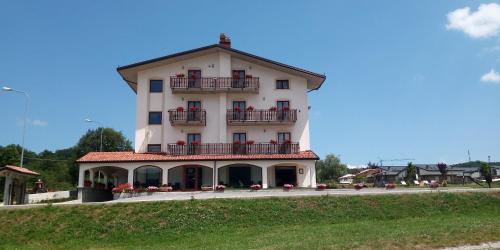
[{"x1": 167, "y1": 143, "x2": 300, "y2": 155}]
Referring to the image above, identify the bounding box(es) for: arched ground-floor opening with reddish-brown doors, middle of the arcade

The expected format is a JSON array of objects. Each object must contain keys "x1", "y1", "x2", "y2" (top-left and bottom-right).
[{"x1": 168, "y1": 165, "x2": 213, "y2": 191}]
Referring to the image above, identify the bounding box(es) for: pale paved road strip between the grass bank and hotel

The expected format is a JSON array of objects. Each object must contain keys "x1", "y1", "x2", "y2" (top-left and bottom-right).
[{"x1": 0, "y1": 188, "x2": 500, "y2": 209}]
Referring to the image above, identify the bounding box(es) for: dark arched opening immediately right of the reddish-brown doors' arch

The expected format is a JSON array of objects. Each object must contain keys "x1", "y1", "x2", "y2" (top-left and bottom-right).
[{"x1": 217, "y1": 164, "x2": 262, "y2": 188}]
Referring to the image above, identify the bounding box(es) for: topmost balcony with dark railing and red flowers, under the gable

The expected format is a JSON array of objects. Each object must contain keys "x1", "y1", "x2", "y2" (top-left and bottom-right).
[{"x1": 170, "y1": 77, "x2": 259, "y2": 93}]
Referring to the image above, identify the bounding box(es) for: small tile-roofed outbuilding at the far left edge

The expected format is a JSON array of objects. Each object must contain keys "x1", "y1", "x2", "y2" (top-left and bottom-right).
[{"x1": 0, "y1": 165, "x2": 40, "y2": 205}]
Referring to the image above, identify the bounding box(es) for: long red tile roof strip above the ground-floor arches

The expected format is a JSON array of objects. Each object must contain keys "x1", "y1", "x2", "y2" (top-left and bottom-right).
[{"x1": 76, "y1": 150, "x2": 319, "y2": 163}]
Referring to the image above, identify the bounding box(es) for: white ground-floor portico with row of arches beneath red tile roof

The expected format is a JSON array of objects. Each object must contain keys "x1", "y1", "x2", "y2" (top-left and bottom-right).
[{"x1": 78, "y1": 160, "x2": 316, "y2": 191}]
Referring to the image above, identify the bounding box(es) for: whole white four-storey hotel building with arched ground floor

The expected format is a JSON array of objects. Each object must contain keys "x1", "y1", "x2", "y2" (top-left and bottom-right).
[{"x1": 74, "y1": 34, "x2": 326, "y2": 196}]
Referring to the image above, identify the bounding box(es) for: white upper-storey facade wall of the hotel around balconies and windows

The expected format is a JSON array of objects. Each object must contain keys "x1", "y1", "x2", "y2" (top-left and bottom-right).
[{"x1": 135, "y1": 52, "x2": 310, "y2": 152}]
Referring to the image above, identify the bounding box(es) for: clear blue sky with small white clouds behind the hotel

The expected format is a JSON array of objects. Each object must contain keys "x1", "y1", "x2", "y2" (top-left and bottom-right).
[{"x1": 0, "y1": 0, "x2": 500, "y2": 165}]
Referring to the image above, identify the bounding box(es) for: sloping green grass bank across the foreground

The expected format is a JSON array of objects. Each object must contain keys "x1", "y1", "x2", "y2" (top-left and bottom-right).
[{"x1": 0, "y1": 193, "x2": 500, "y2": 249}]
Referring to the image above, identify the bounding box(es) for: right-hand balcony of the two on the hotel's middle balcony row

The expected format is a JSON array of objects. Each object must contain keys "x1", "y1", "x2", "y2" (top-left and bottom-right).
[{"x1": 226, "y1": 109, "x2": 297, "y2": 125}]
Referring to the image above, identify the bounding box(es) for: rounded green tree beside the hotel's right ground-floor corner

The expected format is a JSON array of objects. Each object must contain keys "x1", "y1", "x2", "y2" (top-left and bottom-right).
[{"x1": 316, "y1": 154, "x2": 347, "y2": 182}]
